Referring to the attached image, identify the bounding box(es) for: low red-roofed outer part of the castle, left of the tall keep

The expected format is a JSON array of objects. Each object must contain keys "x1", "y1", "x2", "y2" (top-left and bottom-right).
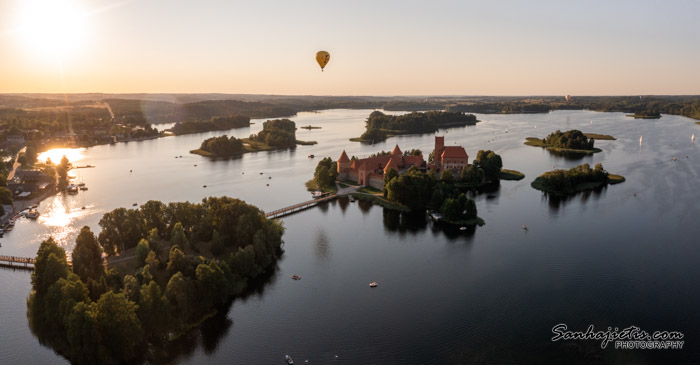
[{"x1": 337, "y1": 145, "x2": 426, "y2": 189}]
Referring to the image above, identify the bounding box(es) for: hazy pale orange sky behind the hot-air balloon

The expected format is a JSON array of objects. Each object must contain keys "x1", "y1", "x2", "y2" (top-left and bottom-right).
[{"x1": 0, "y1": 0, "x2": 700, "y2": 95}]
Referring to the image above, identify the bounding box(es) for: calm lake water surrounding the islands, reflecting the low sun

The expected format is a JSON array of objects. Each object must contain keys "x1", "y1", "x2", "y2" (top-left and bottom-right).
[{"x1": 0, "y1": 110, "x2": 700, "y2": 364}]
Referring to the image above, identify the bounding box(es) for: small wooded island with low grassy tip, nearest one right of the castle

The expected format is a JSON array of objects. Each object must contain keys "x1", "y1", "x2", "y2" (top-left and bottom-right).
[{"x1": 531, "y1": 163, "x2": 625, "y2": 195}]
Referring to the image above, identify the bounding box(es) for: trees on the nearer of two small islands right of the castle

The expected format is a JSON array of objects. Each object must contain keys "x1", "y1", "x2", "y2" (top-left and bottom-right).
[{"x1": 533, "y1": 163, "x2": 609, "y2": 194}]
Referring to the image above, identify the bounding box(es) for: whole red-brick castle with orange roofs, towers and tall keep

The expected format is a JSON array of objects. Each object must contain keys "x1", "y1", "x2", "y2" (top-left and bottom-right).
[{"x1": 337, "y1": 137, "x2": 469, "y2": 189}]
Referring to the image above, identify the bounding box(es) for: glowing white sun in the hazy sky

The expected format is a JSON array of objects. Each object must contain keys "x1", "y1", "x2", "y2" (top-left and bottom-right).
[{"x1": 17, "y1": 0, "x2": 86, "y2": 57}]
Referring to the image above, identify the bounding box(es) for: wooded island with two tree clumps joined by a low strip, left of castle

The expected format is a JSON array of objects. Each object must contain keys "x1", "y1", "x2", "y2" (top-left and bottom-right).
[{"x1": 190, "y1": 119, "x2": 316, "y2": 158}]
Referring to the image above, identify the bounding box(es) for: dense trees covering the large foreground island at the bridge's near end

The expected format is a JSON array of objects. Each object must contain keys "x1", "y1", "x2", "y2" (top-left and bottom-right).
[{"x1": 27, "y1": 197, "x2": 283, "y2": 364}]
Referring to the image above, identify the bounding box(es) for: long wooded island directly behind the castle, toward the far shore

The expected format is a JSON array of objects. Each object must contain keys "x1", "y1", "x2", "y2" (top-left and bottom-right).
[{"x1": 350, "y1": 111, "x2": 478, "y2": 143}]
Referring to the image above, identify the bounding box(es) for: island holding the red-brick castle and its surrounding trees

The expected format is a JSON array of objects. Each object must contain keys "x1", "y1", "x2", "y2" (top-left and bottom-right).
[{"x1": 306, "y1": 136, "x2": 525, "y2": 226}]
